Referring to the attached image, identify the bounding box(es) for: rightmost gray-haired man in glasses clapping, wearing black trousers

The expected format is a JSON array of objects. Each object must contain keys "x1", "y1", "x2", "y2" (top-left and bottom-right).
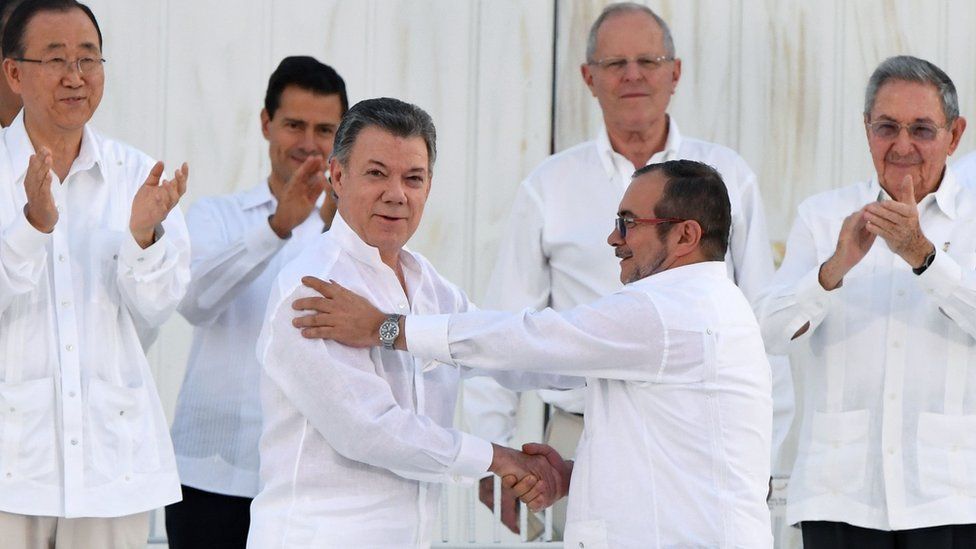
[{"x1": 760, "y1": 56, "x2": 976, "y2": 549}]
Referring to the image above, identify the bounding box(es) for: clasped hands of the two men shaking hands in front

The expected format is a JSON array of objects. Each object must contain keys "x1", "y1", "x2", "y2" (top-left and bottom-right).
[{"x1": 480, "y1": 443, "x2": 573, "y2": 531}]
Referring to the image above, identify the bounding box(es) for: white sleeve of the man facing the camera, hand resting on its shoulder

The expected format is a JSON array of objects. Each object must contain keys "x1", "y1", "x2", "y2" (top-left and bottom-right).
[{"x1": 259, "y1": 286, "x2": 493, "y2": 482}]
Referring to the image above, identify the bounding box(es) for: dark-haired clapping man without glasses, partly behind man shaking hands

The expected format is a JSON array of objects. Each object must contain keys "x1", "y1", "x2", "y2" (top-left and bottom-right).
[{"x1": 166, "y1": 56, "x2": 348, "y2": 549}]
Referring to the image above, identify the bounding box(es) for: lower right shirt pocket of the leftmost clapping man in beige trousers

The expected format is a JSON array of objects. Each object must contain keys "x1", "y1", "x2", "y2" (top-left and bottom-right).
[{"x1": 86, "y1": 378, "x2": 160, "y2": 481}]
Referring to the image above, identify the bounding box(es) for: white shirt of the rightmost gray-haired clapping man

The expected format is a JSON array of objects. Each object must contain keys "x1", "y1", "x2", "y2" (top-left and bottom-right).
[{"x1": 760, "y1": 169, "x2": 976, "y2": 530}]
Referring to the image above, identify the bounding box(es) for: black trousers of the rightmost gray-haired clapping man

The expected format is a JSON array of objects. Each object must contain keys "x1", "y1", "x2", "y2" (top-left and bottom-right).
[{"x1": 800, "y1": 521, "x2": 976, "y2": 549}]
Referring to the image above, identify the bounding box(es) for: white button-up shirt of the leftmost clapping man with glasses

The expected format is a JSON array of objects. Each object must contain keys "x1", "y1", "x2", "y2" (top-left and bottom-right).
[{"x1": 0, "y1": 113, "x2": 190, "y2": 517}]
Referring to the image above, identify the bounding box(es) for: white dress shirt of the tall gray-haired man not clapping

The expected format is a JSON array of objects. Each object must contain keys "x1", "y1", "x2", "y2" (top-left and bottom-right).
[{"x1": 464, "y1": 117, "x2": 793, "y2": 466}]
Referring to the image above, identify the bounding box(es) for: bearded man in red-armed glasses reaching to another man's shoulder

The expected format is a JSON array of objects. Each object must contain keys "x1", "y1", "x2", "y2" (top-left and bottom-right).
[{"x1": 294, "y1": 160, "x2": 772, "y2": 549}]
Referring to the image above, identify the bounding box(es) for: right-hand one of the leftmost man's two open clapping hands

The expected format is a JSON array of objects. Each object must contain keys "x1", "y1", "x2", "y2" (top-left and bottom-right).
[{"x1": 129, "y1": 162, "x2": 189, "y2": 249}]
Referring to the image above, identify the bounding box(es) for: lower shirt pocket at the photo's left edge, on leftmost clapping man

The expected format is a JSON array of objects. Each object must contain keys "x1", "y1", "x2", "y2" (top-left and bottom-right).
[{"x1": 0, "y1": 377, "x2": 59, "y2": 481}]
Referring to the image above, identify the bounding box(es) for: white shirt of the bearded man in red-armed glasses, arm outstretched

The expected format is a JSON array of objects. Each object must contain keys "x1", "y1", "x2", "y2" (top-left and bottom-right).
[{"x1": 405, "y1": 262, "x2": 772, "y2": 549}]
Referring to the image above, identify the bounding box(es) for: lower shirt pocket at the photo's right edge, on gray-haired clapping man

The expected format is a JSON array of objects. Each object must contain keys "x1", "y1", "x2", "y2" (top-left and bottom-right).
[{"x1": 917, "y1": 412, "x2": 976, "y2": 497}]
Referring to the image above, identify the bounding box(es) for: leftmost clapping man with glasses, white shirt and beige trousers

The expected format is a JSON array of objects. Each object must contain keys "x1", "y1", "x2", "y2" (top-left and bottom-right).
[{"x1": 0, "y1": 0, "x2": 190, "y2": 548}]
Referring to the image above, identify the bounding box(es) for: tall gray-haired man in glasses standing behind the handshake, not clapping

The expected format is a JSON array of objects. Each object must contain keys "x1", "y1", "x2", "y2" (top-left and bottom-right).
[{"x1": 464, "y1": 2, "x2": 792, "y2": 531}]
